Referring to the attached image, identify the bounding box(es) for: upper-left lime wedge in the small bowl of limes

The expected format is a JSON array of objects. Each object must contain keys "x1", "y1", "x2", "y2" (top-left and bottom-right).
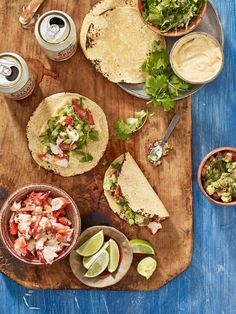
[{"x1": 76, "y1": 230, "x2": 104, "y2": 256}]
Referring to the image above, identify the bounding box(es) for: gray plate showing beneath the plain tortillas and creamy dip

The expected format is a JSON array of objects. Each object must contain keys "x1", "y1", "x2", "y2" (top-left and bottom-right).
[{"x1": 118, "y1": 1, "x2": 224, "y2": 100}]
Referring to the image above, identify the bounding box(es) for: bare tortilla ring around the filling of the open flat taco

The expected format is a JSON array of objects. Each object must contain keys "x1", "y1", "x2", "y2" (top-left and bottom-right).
[{"x1": 27, "y1": 93, "x2": 109, "y2": 177}]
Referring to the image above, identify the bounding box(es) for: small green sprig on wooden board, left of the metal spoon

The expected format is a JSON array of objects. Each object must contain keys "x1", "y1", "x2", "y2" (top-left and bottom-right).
[{"x1": 114, "y1": 110, "x2": 148, "y2": 141}]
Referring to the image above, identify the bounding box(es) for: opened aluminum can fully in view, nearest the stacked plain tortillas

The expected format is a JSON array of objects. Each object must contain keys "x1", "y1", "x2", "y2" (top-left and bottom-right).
[{"x1": 35, "y1": 11, "x2": 77, "y2": 61}]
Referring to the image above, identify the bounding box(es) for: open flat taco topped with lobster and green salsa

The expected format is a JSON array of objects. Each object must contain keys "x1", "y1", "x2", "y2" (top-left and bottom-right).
[{"x1": 27, "y1": 93, "x2": 108, "y2": 177}]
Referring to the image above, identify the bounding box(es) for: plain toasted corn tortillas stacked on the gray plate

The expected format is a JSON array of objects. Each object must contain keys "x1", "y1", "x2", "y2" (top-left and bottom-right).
[{"x1": 80, "y1": 0, "x2": 165, "y2": 84}]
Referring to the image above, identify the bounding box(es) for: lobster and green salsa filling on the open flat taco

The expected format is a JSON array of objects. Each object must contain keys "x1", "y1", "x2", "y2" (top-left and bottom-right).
[{"x1": 38, "y1": 97, "x2": 99, "y2": 168}]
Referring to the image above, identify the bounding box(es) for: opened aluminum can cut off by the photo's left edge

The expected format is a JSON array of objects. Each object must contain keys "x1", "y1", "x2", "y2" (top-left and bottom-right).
[{"x1": 0, "y1": 52, "x2": 35, "y2": 100}]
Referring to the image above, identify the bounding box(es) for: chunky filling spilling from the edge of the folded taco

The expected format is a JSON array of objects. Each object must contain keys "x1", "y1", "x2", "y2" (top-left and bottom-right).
[{"x1": 104, "y1": 155, "x2": 169, "y2": 234}]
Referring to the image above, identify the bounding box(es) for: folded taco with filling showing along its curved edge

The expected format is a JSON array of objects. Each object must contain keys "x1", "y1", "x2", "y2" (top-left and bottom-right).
[{"x1": 103, "y1": 153, "x2": 169, "y2": 234}]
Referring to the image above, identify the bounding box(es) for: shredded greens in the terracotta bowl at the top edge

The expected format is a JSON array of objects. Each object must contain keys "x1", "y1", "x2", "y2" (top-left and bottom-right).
[{"x1": 142, "y1": 0, "x2": 206, "y2": 32}]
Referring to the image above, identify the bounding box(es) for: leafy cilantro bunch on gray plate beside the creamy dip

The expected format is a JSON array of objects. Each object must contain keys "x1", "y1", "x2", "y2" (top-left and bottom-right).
[{"x1": 141, "y1": 40, "x2": 189, "y2": 111}]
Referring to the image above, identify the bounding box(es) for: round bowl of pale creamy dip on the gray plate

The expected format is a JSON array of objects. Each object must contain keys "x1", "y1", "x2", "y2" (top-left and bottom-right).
[{"x1": 170, "y1": 32, "x2": 224, "y2": 84}]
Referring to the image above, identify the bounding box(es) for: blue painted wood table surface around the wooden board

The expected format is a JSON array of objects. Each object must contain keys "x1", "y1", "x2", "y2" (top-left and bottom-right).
[{"x1": 0, "y1": 0, "x2": 236, "y2": 314}]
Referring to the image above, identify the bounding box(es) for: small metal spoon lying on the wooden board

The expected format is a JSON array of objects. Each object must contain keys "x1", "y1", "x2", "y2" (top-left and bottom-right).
[{"x1": 148, "y1": 114, "x2": 180, "y2": 162}]
